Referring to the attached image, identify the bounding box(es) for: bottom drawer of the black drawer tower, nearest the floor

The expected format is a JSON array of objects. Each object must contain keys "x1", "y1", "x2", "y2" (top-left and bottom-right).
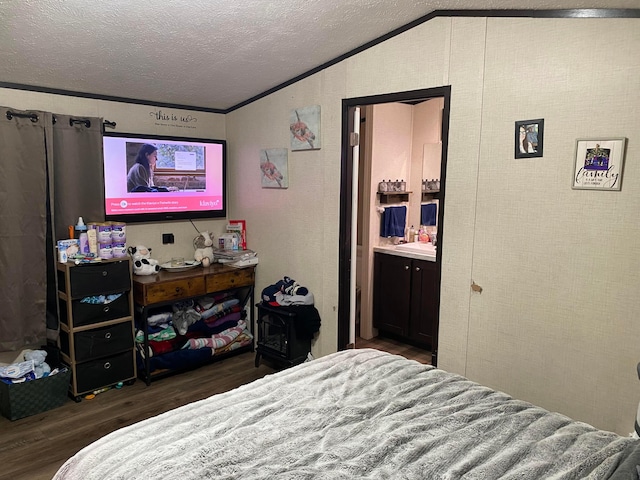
[{"x1": 75, "y1": 350, "x2": 135, "y2": 394}]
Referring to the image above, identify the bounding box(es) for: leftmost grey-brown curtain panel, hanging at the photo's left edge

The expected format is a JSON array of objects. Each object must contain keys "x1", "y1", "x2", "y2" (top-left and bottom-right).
[{"x1": 0, "y1": 107, "x2": 52, "y2": 351}]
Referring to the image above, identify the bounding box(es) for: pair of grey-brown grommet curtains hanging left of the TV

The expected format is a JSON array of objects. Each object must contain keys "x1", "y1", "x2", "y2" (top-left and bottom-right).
[{"x1": 0, "y1": 107, "x2": 104, "y2": 351}]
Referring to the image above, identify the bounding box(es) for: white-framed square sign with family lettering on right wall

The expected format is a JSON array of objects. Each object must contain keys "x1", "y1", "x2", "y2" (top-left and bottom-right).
[{"x1": 571, "y1": 137, "x2": 627, "y2": 190}]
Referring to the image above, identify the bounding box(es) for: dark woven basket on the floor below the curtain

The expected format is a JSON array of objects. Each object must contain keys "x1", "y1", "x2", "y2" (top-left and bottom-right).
[{"x1": 0, "y1": 368, "x2": 71, "y2": 420}]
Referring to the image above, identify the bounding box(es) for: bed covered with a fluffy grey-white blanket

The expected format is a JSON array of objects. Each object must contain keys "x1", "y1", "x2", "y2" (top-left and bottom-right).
[{"x1": 54, "y1": 349, "x2": 640, "y2": 480}]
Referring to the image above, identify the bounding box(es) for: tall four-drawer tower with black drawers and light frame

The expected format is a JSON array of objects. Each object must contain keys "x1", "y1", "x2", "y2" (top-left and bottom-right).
[{"x1": 58, "y1": 257, "x2": 136, "y2": 402}]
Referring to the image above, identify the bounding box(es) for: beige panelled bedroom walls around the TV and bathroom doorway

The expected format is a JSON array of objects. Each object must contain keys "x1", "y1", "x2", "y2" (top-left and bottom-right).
[{"x1": 0, "y1": 17, "x2": 640, "y2": 434}]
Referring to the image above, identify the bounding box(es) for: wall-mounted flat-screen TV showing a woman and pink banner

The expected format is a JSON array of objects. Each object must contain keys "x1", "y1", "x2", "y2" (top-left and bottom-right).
[{"x1": 103, "y1": 132, "x2": 227, "y2": 222}]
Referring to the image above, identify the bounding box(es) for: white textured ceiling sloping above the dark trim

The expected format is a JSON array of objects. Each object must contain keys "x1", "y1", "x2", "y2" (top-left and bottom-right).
[{"x1": 0, "y1": 0, "x2": 640, "y2": 110}]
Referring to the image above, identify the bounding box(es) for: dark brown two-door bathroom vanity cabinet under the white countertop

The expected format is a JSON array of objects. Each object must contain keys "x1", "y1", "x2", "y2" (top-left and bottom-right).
[{"x1": 373, "y1": 252, "x2": 440, "y2": 350}]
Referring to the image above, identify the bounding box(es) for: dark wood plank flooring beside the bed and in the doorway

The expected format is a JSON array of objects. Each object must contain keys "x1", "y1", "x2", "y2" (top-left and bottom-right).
[{"x1": 0, "y1": 339, "x2": 431, "y2": 480}]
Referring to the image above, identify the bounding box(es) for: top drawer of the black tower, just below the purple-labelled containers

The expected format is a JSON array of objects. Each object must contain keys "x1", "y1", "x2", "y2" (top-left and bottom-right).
[{"x1": 58, "y1": 260, "x2": 131, "y2": 298}]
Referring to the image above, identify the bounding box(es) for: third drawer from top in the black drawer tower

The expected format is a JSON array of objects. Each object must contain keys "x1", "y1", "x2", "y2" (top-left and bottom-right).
[{"x1": 73, "y1": 322, "x2": 133, "y2": 362}]
